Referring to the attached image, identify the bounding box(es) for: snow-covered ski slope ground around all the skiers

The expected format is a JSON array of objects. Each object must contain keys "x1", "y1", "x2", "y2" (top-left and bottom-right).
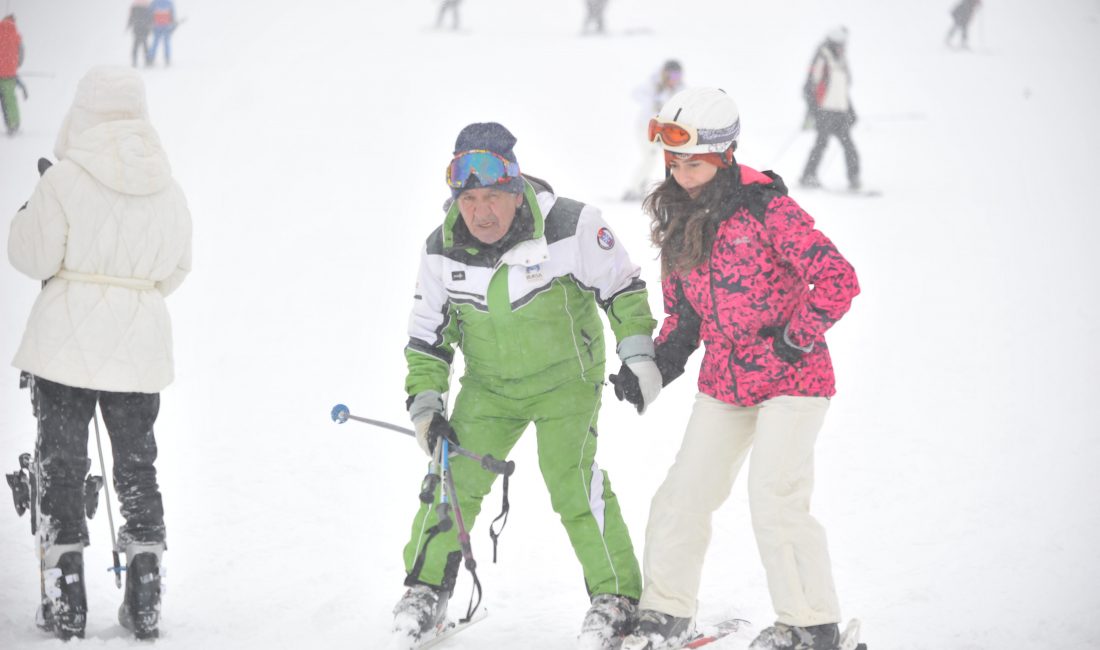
[{"x1": 0, "y1": 0, "x2": 1100, "y2": 650}]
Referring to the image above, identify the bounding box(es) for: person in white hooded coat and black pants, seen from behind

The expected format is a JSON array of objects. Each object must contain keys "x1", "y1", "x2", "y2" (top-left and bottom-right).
[{"x1": 8, "y1": 66, "x2": 191, "y2": 638}]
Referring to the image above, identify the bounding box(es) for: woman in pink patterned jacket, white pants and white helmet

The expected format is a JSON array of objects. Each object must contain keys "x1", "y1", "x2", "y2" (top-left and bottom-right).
[{"x1": 612, "y1": 88, "x2": 859, "y2": 650}]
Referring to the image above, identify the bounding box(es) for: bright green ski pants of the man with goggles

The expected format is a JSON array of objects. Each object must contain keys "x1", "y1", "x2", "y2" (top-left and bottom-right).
[{"x1": 405, "y1": 377, "x2": 641, "y2": 598}]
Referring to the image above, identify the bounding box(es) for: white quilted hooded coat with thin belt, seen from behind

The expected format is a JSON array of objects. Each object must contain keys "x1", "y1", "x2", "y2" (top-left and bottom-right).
[{"x1": 8, "y1": 67, "x2": 191, "y2": 393}]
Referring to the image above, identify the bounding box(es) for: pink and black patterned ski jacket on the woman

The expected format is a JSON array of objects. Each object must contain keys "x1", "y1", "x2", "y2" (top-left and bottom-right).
[{"x1": 656, "y1": 165, "x2": 859, "y2": 406}]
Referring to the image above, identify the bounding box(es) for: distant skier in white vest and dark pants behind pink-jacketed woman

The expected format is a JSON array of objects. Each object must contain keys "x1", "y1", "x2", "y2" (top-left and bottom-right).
[{"x1": 800, "y1": 26, "x2": 860, "y2": 190}]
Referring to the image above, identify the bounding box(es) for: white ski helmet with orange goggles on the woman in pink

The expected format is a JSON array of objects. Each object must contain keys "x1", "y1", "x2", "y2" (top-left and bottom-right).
[{"x1": 649, "y1": 88, "x2": 741, "y2": 154}]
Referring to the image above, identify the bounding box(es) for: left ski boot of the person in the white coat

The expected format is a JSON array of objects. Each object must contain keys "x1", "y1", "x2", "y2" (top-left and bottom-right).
[{"x1": 35, "y1": 543, "x2": 88, "y2": 641}]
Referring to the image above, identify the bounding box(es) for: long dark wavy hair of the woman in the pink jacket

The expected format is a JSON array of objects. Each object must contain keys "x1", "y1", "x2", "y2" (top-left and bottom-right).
[{"x1": 641, "y1": 161, "x2": 741, "y2": 277}]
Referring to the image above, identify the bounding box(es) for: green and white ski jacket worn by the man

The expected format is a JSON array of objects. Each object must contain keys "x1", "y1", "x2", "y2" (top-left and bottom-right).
[{"x1": 405, "y1": 178, "x2": 657, "y2": 399}]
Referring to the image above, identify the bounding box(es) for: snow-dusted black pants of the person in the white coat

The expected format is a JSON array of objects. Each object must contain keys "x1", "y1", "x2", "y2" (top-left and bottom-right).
[{"x1": 33, "y1": 377, "x2": 165, "y2": 549}]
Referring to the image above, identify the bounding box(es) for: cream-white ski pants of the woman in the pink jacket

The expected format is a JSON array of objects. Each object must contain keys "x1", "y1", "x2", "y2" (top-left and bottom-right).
[{"x1": 640, "y1": 393, "x2": 840, "y2": 627}]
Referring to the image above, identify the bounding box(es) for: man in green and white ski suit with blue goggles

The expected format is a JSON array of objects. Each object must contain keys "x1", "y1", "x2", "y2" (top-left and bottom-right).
[{"x1": 394, "y1": 122, "x2": 660, "y2": 648}]
